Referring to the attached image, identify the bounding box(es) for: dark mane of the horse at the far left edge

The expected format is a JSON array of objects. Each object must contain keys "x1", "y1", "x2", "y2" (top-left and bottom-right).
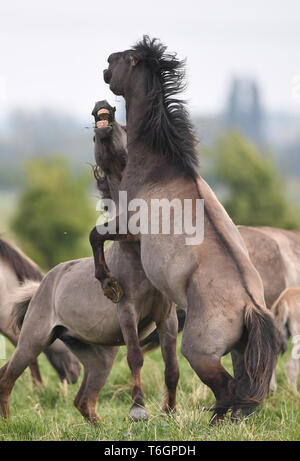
[{"x1": 0, "y1": 239, "x2": 43, "y2": 283}]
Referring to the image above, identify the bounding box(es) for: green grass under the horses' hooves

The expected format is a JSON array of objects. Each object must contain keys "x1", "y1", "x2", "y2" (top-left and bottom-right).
[{"x1": 0, "y1": 336, "x2": 300, "y2": 441}]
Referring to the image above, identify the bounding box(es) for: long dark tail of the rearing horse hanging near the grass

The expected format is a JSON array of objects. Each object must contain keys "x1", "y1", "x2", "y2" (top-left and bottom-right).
[{"x1": 237, "y1": 304, "x2": 279, "y2": 405}]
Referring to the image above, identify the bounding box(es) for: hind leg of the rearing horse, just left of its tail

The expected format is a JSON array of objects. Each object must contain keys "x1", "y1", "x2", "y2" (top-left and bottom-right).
[{"x1": 181, "y1": 280, "x2": 242, "y2": 424}]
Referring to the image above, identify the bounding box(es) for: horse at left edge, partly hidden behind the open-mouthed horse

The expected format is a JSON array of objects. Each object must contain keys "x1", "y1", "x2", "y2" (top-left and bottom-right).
[{"x1": 0, "y1": 239, "x2": 80, "y2": 383}]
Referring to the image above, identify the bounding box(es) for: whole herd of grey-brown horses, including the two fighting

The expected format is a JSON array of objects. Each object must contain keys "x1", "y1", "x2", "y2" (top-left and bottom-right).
[{"x1": 0, "y1": 36, "x2": 300, "y2": 423}]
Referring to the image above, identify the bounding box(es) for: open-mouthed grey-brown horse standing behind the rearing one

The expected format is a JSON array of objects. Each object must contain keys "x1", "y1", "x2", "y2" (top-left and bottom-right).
[{"x1": 0, "y1": 105, "x2": 179, "y2": 423}]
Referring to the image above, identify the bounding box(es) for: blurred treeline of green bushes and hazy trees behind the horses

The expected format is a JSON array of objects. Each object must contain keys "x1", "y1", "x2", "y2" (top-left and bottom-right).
[{"x1": 0, "y1": 78, "x2": 300, "y2": 270}]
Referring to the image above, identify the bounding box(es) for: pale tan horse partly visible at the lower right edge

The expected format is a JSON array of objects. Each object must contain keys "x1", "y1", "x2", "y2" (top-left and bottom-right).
[{"x1": 271, "y1": 287, "x2": 300, "y2": 391}]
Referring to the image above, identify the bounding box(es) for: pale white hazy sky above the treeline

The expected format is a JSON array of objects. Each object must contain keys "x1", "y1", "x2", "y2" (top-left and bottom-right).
[{"x1": 0, "y1": 0, "x2": 300, "y2": 119}]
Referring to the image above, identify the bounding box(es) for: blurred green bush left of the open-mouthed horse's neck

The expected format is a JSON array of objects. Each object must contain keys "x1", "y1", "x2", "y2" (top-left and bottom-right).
[{"x1": 11, "y1": 156, "x2": 95, "y2": 269}]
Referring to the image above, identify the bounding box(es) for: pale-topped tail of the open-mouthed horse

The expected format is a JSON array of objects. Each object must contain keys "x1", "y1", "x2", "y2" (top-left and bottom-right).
[{"x1": 10, "y1": 280, "x2": 41, "y2": 332}]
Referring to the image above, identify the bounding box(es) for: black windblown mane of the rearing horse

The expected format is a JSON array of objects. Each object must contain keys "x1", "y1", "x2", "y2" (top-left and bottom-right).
[{"x1": 132, "y1": 35, "x2": 199, "y2": 177}]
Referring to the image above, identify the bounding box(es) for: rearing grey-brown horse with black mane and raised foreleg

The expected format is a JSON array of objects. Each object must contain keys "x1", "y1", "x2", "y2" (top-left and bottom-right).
[{"x1": 90, "y1": 36, "x2": 277, "y2": 422}]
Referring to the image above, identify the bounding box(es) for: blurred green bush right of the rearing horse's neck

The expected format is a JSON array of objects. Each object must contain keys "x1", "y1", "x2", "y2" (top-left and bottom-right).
[{"x1": 203, "y1": 132, "x2": 299, "y2": 229}]
